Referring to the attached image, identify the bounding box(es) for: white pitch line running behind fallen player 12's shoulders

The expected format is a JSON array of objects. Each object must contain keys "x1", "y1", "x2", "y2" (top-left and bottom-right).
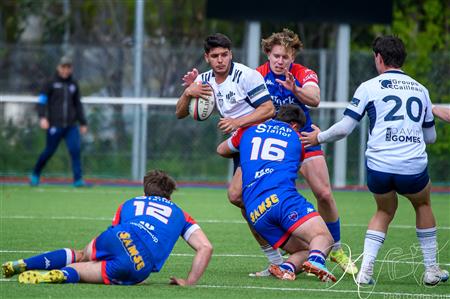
[{"x1": 0, "y1": 215, "x2": 450, "y2": 230}]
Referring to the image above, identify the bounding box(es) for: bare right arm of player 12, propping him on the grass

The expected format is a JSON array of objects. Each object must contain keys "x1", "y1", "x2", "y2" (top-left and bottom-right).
[{"x1": 170, "y1": 229, "x2": 213, "y2": 286}]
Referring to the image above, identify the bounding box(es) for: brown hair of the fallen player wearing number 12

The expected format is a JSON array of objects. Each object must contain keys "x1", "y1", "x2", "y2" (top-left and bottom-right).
[{"x1": 144, "y1": 169, "x2": 177, "y2": 199}]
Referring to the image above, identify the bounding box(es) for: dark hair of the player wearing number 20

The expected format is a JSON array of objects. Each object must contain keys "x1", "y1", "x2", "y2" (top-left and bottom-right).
[{"x1": 372, "y1": 35, "x2": 406, "y2": 68}]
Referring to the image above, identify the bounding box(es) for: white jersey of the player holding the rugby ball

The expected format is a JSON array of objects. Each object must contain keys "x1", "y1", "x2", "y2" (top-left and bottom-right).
[{"x1": 195, "y1": 62, "x2": 271, "y2": 118}]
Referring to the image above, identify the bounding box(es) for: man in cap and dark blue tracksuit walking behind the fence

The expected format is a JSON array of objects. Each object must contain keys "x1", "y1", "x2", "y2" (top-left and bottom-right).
[{"x1": 30, "y1": 56, "x2": 87, "y2": 187}]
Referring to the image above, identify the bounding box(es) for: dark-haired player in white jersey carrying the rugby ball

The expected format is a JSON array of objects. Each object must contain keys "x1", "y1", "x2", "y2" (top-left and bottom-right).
[{"x1": 176, "y1": 33, "x2": 283, "y2": 274}]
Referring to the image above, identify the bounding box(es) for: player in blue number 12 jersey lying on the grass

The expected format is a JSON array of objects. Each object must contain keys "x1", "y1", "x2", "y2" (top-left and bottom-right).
[{"x1": 2, "y1": 170, "x2": 212, "y2": 286}]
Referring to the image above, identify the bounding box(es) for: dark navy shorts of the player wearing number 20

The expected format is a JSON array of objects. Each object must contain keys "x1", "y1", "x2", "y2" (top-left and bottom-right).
[{"x1": 367, "y1": 167, "x2": 430, "y2": 194}]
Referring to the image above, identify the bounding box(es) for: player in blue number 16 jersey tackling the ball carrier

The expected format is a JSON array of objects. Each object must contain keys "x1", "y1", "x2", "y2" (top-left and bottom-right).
[{"x1": 217, "y1": 105, "x2": 336, "y2": 281}]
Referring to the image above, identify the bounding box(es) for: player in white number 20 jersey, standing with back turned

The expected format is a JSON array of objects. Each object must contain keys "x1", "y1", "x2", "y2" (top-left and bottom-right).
[{"x1": 302, "y1": 36, "x2": 449, "y2": 285}]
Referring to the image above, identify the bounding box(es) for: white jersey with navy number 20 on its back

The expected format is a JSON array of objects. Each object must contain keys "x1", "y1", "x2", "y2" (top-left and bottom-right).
[{"x1": 344, "y1": 70, "x2": 434, "y2": 175}]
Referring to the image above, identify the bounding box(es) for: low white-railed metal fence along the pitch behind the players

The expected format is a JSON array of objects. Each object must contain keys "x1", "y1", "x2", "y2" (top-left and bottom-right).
[{"x1": 0, "y1": 95, "x2": 449, "y2": 185}]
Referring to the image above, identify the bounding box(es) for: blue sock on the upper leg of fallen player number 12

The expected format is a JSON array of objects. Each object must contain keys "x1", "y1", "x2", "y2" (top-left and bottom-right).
[{"x1": 23, "y1": 248, "x2": 75, "y2": 270}]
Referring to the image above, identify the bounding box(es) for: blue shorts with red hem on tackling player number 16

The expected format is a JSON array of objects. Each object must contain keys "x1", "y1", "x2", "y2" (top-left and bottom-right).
[{"x1": 245, "y1": 189, "x2": 319, "y2": 249}]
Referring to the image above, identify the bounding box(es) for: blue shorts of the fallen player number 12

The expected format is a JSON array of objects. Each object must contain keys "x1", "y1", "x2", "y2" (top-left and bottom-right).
[{"x1": 92, "y1": 224, "x2": 153, "y2": 285}]
